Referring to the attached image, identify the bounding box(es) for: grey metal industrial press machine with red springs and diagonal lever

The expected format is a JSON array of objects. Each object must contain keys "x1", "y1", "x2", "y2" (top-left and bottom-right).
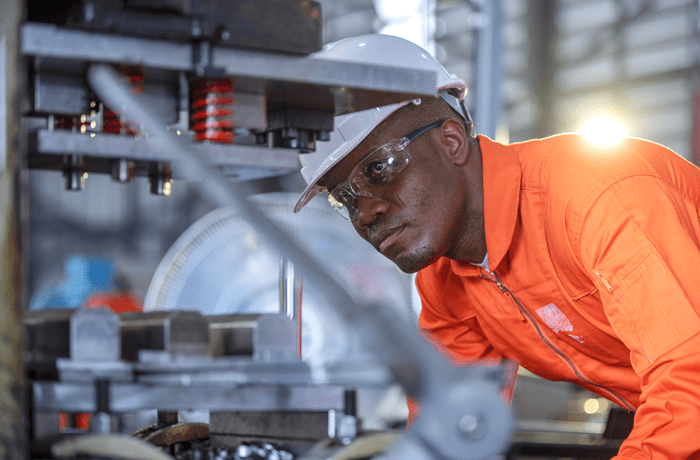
[{"x1": 3, "y1": 0, "x2": 511, "y2": 460}]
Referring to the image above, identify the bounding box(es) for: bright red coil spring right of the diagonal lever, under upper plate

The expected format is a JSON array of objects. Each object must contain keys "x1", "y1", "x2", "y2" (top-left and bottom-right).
[{"x1": 192, "y1": 78, "x2": 233, "y2": 144}]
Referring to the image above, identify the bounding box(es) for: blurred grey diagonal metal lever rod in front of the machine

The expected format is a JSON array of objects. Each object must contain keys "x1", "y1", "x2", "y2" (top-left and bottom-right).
[{"x1": 88, "y1": 64, "x2": 449, "y2": 397}]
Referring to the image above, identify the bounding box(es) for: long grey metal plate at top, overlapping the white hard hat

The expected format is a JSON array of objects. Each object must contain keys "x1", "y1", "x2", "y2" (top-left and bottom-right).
[{"x1": 20, "y1": 22, "x2": 436, "y2": 113}]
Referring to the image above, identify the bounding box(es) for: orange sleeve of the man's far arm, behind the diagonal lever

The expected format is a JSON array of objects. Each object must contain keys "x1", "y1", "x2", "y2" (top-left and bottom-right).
[{"x1": 408, "y1": 267, "x2": 518, "y2": 425}]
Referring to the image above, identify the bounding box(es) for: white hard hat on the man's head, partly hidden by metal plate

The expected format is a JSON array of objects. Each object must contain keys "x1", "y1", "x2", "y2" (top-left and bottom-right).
[{"x1": 294, "y1": 34, "x2": 471, "y2": 212}]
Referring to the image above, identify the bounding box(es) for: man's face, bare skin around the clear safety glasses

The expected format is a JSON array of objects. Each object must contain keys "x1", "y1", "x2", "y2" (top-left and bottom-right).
[{"x1": 323, "y1": 118, "x2": 474, "y2": 273}]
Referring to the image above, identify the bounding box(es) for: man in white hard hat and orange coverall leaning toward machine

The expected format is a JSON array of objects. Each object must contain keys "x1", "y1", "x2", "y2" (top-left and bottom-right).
[{"x1": 295, "y1": 36, "x2": 700, "y2": 459}]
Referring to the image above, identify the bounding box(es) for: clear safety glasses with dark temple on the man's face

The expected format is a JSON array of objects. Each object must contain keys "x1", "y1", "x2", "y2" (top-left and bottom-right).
[{"x1": 328, "y1": 120, "x2": 445, "y2": 222}]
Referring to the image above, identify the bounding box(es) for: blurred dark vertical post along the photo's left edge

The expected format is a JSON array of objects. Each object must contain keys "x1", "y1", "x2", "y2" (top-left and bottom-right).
[{"x1": 0, "y1": 0, "x2": 29, "y2": 459}]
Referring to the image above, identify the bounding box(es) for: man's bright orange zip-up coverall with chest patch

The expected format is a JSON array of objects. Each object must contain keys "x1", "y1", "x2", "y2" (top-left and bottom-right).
[{"x1": 417, "y1": 134, "x2": 700, "y2": 460}]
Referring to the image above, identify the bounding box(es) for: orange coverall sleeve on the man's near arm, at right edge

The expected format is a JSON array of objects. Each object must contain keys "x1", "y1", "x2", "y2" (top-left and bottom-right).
[{"x1": 573, "y1": 176, "x2": 700, "y2": 460}]
